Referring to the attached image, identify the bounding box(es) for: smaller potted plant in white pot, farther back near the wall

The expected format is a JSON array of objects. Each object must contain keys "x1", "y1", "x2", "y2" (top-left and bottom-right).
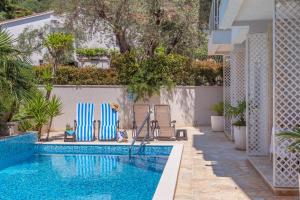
[{"x1": 210, "y1": 102, "x2": 224, "y2": 131}]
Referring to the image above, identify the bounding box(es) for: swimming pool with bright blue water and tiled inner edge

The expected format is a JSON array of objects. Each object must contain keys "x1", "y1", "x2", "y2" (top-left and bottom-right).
[{"x1": 0, "y1": 133, "x2": 180, "y2": 200}]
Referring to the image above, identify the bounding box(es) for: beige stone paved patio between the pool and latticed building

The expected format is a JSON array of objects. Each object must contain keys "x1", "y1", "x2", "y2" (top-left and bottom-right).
[{"x1": 44, "y1": 127, "x2": 298, "y2": 200}]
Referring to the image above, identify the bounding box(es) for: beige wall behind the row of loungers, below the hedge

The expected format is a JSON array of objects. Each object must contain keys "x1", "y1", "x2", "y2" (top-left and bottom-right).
[{"x1": 52, "y1": 85, "x2": 223, "y2": 131}]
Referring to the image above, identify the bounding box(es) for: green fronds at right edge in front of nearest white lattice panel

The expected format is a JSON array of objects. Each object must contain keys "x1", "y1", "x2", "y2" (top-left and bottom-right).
[{"x1": 277, "y1": 128, "x2": 300, "y2": 188}]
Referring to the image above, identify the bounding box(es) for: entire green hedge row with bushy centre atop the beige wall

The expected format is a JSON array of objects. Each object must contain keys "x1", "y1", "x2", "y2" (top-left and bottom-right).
[{"x1": 35, "y1": 52, "x2": 223, "y2": 87}]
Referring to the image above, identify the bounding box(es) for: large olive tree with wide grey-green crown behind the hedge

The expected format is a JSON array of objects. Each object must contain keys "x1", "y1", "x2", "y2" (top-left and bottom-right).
[{"x1": 54, "y1": 0, "x2": 206, "y2": 57}]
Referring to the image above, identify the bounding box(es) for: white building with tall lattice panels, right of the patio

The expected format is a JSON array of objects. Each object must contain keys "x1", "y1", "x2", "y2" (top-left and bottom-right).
[{"x1": 209, "y1": 0, "x2": 300, "y2": 195}]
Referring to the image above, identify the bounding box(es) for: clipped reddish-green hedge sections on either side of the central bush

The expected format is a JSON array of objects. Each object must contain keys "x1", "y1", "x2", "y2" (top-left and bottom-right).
[{"x1": 34, "y1": 58, "x2": 223, "y2": 86}]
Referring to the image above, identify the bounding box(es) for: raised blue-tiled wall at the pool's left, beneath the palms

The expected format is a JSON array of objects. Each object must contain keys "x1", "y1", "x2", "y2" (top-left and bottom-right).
[{"x1": 0, "y1": 133, "x2": 37, "y2": 169}]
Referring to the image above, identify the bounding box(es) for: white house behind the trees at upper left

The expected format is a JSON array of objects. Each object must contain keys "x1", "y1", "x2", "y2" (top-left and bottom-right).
[{"x1": 0, "y1": 11, "x2": 117, "y2": 68}]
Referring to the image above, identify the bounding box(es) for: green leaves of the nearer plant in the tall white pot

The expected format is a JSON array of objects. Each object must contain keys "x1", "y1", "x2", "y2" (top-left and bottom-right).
[{"x1": 226, "y1": 101, "x2": 247, "y2": 126}]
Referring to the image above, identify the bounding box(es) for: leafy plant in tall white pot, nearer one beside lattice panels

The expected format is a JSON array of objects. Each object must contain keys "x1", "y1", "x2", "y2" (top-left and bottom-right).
[{"x1": 228, "y1": 101, "x2": 246, "y2": 150}]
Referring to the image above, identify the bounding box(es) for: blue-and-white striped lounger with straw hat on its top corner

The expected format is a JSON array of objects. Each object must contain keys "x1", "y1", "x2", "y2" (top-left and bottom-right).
[{"x1": 98, "y1": 103, "x2": 119, "y2": 141}]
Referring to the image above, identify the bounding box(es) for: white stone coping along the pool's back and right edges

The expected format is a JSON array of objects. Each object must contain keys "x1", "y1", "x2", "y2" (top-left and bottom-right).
[{"x1": 35, "y1": 142, "x2": 184, "y2": 200}]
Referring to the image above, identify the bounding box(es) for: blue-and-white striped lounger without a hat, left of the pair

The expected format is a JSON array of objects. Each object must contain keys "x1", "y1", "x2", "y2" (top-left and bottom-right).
[{"x1": 75, "y1": 103, "x2": 95, "y2": 142}]
